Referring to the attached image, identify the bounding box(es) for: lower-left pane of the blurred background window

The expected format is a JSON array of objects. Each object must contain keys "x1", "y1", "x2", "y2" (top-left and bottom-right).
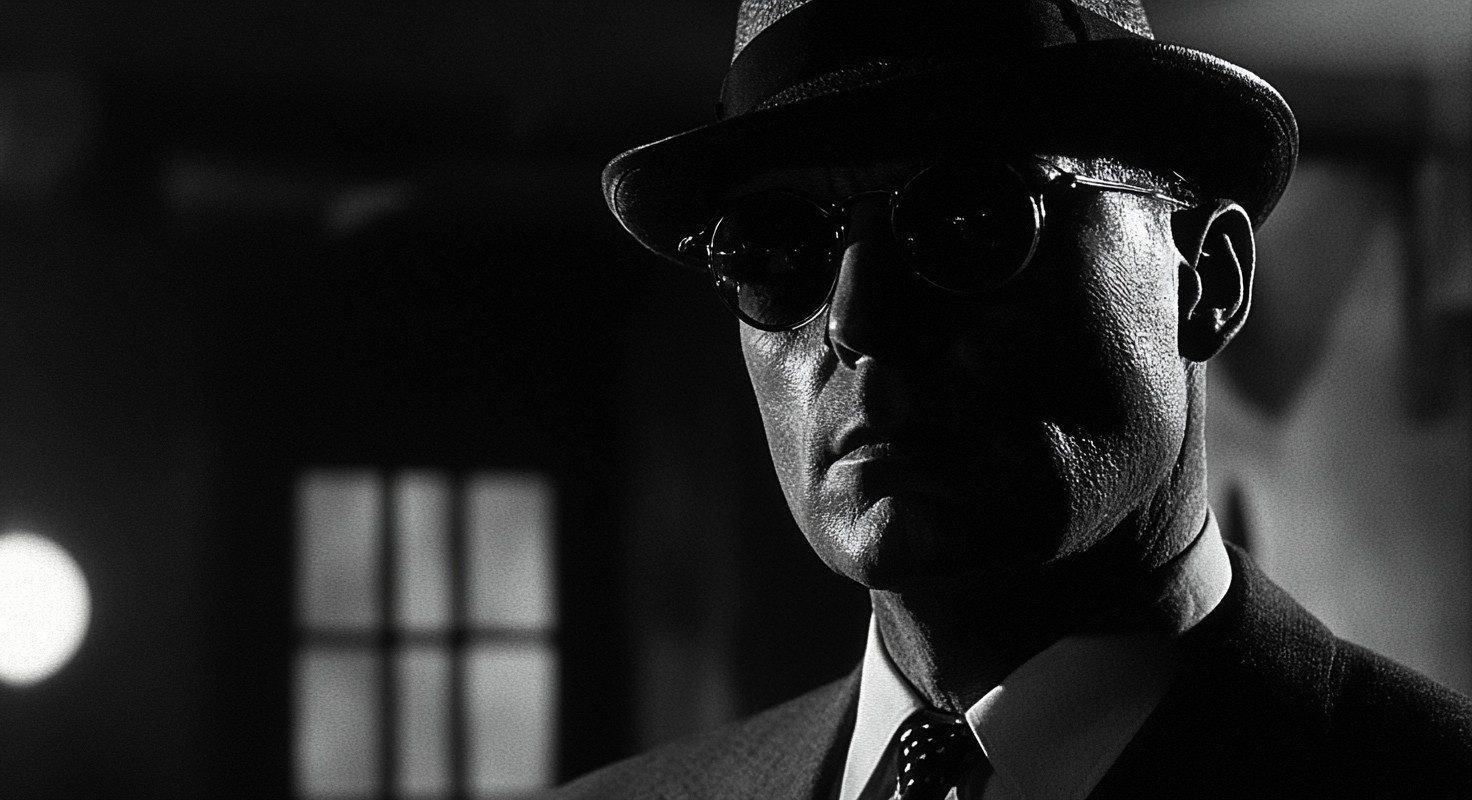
[{"x1": 296, "y1": 648, "x2": 383, "y2": 797}]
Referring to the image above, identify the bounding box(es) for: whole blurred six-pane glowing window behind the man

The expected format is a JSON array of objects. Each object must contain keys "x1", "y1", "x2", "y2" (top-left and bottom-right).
[{"x1": 294, "y1": 469, "x2": 558, "y2": 799}]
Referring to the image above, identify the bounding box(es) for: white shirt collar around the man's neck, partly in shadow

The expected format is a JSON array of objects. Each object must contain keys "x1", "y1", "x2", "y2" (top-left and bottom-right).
[{"x1": 839, "y1": 513, "x2": 1232, "y2": 800}]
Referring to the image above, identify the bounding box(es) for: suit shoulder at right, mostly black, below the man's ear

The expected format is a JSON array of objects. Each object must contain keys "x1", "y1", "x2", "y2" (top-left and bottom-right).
[{"x1": 1098, "y1": 551, "x2": 1472, "y2": 797}]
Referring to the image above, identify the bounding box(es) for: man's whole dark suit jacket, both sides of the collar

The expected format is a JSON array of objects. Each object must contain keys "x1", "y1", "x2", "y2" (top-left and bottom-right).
[{"x1": 553, "y1": 550, "x2": 1472, "y2": 800}]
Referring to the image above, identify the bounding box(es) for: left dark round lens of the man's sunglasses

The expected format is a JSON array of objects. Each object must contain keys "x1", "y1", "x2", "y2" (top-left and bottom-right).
[{"x1": 711, "y1": 192, "x2": 842, "y2": 330}]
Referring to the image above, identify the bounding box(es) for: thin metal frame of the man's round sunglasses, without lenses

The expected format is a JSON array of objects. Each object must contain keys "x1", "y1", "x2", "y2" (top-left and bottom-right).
[{"x1": 676, "y1": 159, "x2": 1192, "y2": 331}]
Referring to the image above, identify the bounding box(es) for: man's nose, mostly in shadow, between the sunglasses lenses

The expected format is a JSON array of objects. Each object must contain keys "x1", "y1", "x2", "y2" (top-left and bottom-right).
[{"x1": 827, "y1": 199, "x2": 920, "y2": 367}]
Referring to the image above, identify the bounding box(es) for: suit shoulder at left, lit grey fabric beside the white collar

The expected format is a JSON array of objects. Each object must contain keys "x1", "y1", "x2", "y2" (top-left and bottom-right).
[{"x1": 548, "y1": 676, "x2": 855, "y2": 800}]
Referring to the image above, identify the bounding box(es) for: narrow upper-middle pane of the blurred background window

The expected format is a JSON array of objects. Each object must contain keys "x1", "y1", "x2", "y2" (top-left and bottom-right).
[{"x1": 393, "y1": 471, "x2": 450, "y2": 631}]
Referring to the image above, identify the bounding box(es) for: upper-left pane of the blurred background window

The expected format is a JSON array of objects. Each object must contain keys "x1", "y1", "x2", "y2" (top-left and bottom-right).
[{"x1": 296, "y1": 470, "x2": 381, "y2": 631}]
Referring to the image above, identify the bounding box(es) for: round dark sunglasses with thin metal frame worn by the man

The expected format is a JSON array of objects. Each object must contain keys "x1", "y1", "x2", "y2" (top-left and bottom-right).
[{"x1": 677, "y1": 162, "x2": 1191, "y2": 330}]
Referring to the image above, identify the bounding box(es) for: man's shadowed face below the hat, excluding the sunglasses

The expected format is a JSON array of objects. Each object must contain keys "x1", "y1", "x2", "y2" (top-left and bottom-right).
[{"x1": 739, "y1": 159, "x2": 1188, "y2": 589}]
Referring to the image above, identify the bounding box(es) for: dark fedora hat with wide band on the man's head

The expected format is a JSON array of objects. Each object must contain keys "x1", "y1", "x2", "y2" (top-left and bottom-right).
[{"x1": 604, "y1": 0, "x2": 1298, "y2": 269}]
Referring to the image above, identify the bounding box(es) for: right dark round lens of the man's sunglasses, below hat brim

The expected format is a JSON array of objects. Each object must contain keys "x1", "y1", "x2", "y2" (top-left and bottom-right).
[{"x1": 894, "y1": 164, "x2": 1042, "y2": 292}]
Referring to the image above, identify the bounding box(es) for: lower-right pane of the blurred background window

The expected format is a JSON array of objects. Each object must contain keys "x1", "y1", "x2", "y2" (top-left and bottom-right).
[{"x1": 465, "y1": 644, "x2": 556, "y2": 797}]
